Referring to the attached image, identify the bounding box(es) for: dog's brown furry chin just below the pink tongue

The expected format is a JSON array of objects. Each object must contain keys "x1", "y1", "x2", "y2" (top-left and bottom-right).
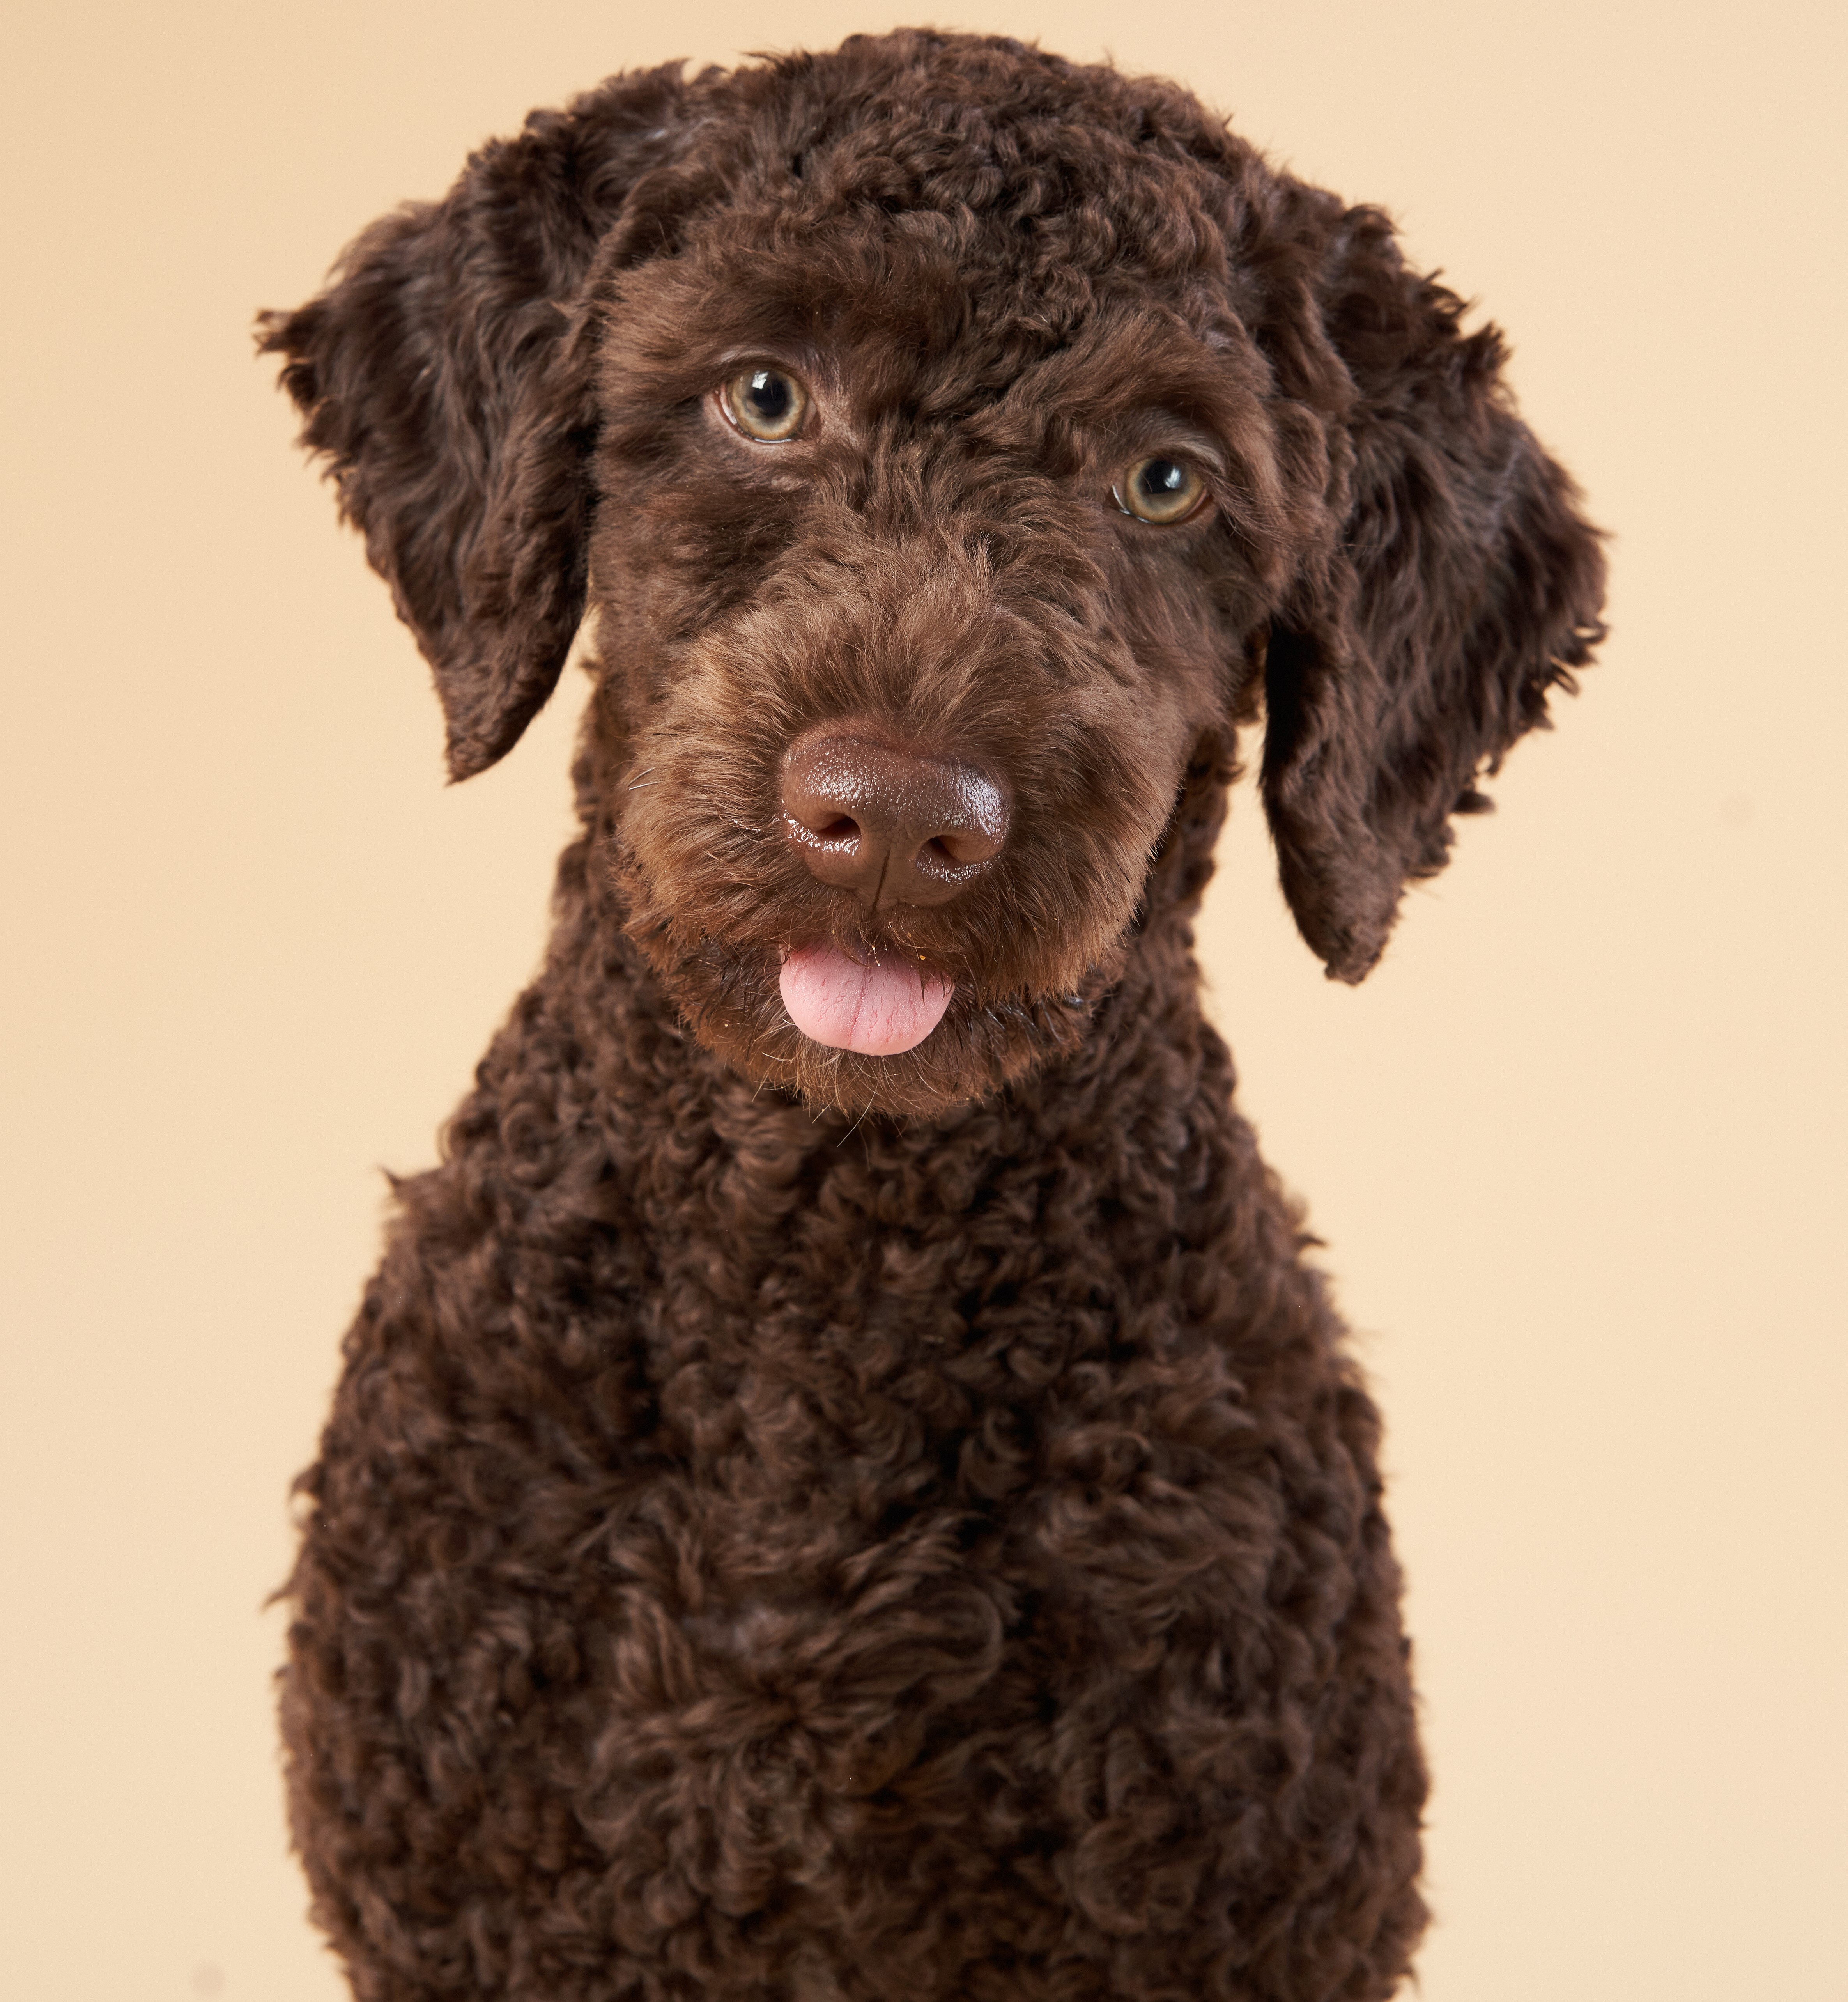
[{"x1": 639, "y1": 937, "x2": 1115, "y2": 1119}]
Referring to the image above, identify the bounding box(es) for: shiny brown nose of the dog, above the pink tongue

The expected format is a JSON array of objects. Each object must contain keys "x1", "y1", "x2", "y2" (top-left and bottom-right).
[{"x1": 783, "y1": 731, "x2": 1007, "y2": 905}]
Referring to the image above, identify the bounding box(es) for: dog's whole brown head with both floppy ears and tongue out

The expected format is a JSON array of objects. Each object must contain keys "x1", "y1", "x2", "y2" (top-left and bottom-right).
[{"x1": 262, "y1": 34, "x2": 1602, "y2": 1111}]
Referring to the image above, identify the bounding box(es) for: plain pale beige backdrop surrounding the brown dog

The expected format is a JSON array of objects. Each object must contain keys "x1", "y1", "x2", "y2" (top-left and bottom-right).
[{"x1": 0, "y1": 0, "x2": 1848, "y2": 2002}]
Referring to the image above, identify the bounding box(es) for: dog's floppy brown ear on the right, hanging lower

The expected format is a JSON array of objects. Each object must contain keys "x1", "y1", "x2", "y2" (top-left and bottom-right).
[{"x1": 1263, "y1": 186, "x2": 1604, "y2": 981}]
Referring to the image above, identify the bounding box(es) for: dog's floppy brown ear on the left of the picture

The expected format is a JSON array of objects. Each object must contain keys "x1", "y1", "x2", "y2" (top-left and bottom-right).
[{"x1": 258, "y1": 64, "x2": 707, "y2": 779}]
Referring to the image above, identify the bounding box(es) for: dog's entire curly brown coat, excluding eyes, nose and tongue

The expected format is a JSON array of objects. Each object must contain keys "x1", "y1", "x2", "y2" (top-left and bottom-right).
[{"x1": 264, "y1": 32, "x2": 1602, "y2": 2002}]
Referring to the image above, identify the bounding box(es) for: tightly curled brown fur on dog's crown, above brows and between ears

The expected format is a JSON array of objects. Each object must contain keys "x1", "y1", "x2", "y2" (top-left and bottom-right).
[{"x1": 600, "y1": 44, "x2": 1251, "y2": 362}]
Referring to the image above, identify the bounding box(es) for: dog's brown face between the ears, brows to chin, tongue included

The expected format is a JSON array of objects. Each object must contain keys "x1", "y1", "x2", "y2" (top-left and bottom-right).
[{"x1": 591, "y1": 203, "x2": 1283, "y2": 1111}]
